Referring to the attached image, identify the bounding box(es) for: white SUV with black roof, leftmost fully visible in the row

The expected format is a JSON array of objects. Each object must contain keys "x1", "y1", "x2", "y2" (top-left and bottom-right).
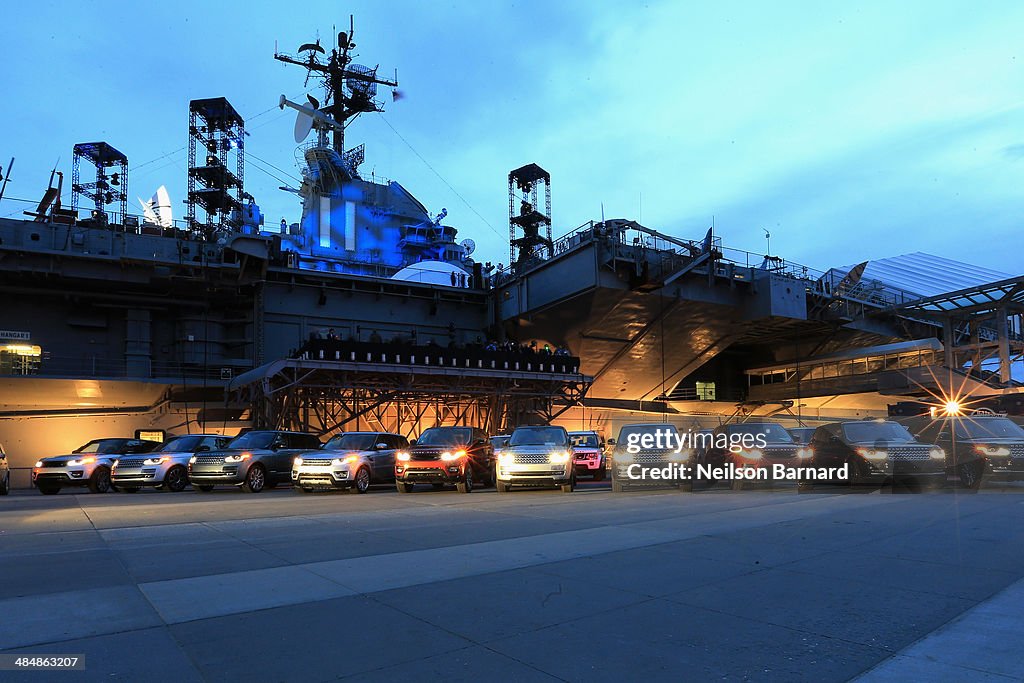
[{"x1": 32, "y1": 438, "x2": 160, "y2": 496}]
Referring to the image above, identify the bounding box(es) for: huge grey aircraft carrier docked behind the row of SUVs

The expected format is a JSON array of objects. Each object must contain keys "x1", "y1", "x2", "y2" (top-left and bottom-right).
[{"x1": 0, "y1": 18, "x2": 1024, "y2": 485}]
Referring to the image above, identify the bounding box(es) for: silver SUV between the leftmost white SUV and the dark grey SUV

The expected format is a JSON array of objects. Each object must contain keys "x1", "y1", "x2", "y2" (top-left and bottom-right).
[{"x1": 111, "y1": 434, "x2": 231, "y2": 494}]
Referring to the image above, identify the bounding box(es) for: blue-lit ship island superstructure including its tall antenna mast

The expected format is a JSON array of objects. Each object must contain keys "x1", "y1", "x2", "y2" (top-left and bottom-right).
[{"x1": 274, "y1": 21, "x2": 473, "y2": 276}]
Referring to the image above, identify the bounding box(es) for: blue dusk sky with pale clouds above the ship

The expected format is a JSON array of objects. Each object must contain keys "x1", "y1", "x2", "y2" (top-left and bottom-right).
[{"x1": 0, "y1": 0, "x2": 1024, "y2": 274}]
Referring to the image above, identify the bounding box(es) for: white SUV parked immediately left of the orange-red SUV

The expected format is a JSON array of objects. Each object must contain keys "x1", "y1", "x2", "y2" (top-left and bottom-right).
[{"x1": 292, "y1": 432, "x2": 409, "y2": 494}]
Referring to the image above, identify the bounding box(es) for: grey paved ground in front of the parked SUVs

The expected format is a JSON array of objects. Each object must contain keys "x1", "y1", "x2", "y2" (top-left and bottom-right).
[{"x1": 0, "y1": 483, "x2": 1024, "y2": 682}]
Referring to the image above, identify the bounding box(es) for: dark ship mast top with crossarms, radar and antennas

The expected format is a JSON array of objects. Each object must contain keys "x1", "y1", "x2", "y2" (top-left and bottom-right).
[{"x1": 273, "y1": 16, "x2": 398, "y2": 156}]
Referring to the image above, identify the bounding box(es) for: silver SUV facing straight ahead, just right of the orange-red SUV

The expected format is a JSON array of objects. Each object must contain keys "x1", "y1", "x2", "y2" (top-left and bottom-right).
[{"x1": 496, "y1": 427, "x2": 575, "y2": 494}]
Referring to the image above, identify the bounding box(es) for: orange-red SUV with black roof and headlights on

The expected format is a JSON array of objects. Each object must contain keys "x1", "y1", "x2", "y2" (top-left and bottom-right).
[{"x1": 394, "y1": 427, "x2": 495, "y2": 494}]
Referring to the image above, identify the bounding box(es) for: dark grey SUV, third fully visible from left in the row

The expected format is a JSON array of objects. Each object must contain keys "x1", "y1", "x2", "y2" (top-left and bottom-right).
[{"x1": 188, "y1": 430, "x2": 321, "y2": 494}]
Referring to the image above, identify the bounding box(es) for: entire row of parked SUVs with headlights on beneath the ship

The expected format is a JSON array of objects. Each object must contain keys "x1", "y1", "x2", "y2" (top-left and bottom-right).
[{"x1": 28, "y1": 416, "x2": 1024, "y2": 495}]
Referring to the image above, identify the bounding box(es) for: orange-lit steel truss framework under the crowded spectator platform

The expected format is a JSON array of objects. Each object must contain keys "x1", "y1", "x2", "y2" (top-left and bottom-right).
[{"x1": 228, "y1": 359, "x2": 590, "y2": 436}]
